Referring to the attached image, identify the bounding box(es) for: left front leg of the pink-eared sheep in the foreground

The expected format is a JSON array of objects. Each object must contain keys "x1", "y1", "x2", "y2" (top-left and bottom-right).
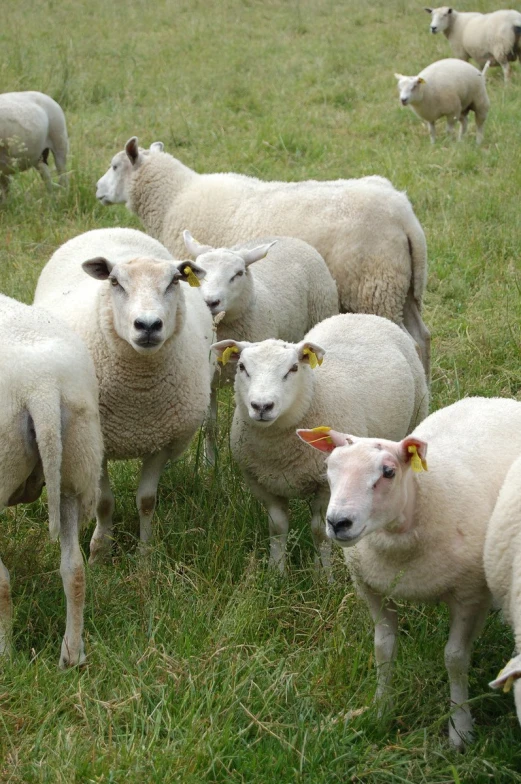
[{"x1": 358, "y1": 583, "x2": 398, "y2": 716}]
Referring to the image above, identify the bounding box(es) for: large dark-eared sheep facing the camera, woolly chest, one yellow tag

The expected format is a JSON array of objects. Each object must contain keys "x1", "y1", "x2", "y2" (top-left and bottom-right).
[{"x1": 35, "y1": 228, "x2": 213, "y2": 563}]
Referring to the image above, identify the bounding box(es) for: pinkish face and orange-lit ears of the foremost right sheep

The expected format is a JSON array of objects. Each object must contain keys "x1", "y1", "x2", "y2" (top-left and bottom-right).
[{"x1": 297, "y1": 428, "x2": 427, "y2": 547}]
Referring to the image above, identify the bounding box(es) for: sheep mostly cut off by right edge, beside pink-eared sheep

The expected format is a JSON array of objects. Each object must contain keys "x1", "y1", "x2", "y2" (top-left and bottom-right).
[{"x1": 484, "y1": 457, "x2": 521, "y2": 724}]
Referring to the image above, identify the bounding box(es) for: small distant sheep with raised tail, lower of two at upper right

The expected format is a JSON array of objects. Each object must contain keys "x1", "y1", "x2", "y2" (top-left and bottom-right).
[{"x1": 395, "y1": 58, "x2": 490, "y2": 144}]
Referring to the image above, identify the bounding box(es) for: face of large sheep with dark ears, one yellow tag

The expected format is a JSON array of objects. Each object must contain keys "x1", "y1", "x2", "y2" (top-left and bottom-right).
[{"x1": 82, "y1": 258, "x2": 204, "y2": 354}]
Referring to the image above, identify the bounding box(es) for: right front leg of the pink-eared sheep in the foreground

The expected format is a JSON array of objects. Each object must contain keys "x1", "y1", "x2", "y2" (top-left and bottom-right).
[{"x1": 445, "y1": 596, "x2": 490, "y2": 750}]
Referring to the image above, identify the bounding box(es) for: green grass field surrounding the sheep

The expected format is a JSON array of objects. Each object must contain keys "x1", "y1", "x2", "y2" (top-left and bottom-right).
[{"x1": 0, "y1": 0, "x2": 521, "y2": 784}]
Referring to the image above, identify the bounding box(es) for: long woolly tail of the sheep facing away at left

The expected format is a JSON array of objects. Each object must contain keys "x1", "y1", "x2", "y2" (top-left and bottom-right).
[{"x1": 28, "y1": 389, "x2": 62, "y2": 542}]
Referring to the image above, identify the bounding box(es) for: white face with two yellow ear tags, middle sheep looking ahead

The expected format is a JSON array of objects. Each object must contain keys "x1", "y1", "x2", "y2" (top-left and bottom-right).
[{"x1": 212, "y1": 340, "x2": 325, "y2": 428}]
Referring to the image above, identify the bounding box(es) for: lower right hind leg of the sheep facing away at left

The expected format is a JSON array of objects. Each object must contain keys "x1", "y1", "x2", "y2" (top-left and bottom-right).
[{"x1": 60, "y1": 495, "x2": 85, "y2": 669}]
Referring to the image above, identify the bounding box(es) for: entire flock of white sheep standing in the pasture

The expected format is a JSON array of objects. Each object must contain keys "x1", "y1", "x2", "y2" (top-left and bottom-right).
[{"x1": 0, "y1": 3, "x2": 521, "y2": 748}]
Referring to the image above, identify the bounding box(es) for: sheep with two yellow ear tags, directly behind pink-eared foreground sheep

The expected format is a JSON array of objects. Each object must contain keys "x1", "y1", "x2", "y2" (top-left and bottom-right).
[{"x1": 212, "y1": 313, "x2": 428, "y2": 576}]
